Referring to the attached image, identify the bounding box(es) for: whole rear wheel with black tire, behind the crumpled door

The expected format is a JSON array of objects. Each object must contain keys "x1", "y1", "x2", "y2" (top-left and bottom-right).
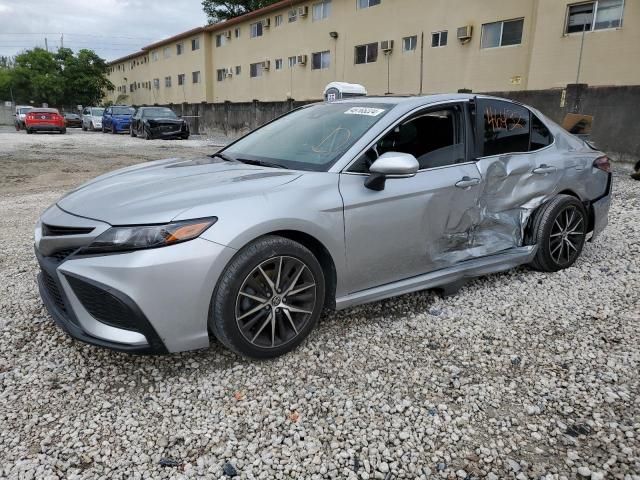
[{"x1": 531, "y1": 195, "x2": 588, "y2": 272}]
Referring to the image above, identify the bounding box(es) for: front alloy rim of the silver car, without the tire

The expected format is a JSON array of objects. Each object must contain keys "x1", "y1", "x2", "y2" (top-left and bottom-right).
[{"x1": 235, "y1": 256, "x2": 317, "y2": 348}]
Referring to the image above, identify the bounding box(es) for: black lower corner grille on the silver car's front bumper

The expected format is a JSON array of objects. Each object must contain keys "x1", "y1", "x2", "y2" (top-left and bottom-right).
[{"x1": 67, "y1": 276, "x2": 137, "y2": 331}]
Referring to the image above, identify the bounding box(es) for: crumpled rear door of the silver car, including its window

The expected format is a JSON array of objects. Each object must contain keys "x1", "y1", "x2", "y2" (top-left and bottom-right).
[{"x1": 475, "y1": 98, "x2": 562, "y2": 255}]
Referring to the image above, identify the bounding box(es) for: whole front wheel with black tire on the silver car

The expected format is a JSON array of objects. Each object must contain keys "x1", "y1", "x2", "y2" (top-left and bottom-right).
[{"x1": 209, "y1": 236, "x2": 325, "y2": 359}]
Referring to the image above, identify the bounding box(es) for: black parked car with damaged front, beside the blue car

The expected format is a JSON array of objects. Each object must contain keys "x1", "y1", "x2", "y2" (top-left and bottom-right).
[{"x1": 129, "y1": 107, "x2": 189, "y2": 140}]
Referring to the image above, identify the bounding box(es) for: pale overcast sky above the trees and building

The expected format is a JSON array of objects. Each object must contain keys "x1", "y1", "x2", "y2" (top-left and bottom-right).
[{"x1": 0, "y1": 0, "x2": 207, "y2": 60}]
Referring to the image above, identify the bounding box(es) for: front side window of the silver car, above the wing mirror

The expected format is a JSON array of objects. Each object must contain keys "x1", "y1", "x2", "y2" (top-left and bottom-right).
[{"x1": 349, "y1": 106, "x2": 465, "y2": 173}]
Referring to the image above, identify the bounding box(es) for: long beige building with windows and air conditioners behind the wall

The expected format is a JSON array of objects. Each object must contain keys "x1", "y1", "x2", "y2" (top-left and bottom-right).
[{"x1": 107, "y1": 0, "x2": 640, "y2": 104}]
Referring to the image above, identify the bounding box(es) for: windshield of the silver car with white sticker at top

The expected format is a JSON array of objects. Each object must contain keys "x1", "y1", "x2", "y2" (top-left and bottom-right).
[{"x1": 224, "y1": 103, "x2": 395, "y2": 171}]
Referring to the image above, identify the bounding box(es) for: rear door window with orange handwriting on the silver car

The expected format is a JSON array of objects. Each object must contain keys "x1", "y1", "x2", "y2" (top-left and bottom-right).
[{"x1": 478, "y1": 99, "x2": 531, "y2": 157}]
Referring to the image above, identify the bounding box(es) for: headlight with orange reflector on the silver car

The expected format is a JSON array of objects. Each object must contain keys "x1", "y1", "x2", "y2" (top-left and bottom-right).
[{"x1": 80, "y1": 217, "x2": 218, "y2": 254}]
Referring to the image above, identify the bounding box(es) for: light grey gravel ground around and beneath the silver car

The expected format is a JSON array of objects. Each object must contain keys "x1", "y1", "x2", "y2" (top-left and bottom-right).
[{"x1": 0, "y1": 128, "x2": 640, "y2": 480}]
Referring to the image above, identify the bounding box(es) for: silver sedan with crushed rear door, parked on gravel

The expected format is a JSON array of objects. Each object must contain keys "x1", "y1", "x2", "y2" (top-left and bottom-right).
[{"x1": 35, "y1": 95, "x2": 611, "y2": 358}]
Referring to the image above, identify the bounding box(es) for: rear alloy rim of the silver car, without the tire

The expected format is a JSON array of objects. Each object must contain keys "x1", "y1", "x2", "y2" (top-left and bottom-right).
[{"x1": 549, "y1": 205, "x2": 585, "y2": 265}]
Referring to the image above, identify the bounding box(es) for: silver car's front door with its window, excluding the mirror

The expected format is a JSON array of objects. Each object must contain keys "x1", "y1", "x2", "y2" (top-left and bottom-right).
[{"x1": 340, "y1": 105, "x2": 481, "y2": 293}]
